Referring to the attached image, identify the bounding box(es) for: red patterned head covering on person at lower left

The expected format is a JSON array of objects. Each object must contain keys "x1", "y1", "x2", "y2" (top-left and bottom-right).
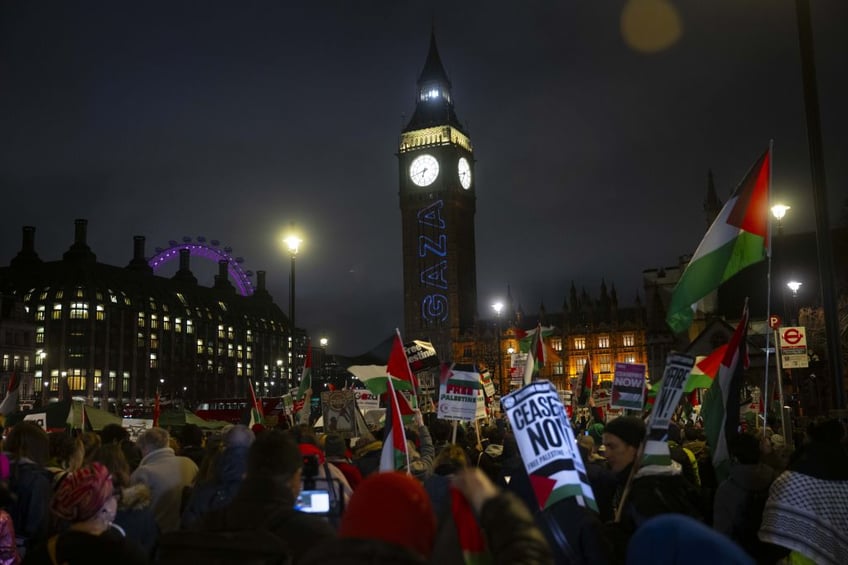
[{"x1": 51, "y1": 463, "x2": 112, "y2": 522}]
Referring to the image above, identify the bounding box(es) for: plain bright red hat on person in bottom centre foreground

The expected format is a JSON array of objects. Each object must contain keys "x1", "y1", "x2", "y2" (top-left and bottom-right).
[{"x1": 339, "y1": 473, "x2": 436, "y2": 557}]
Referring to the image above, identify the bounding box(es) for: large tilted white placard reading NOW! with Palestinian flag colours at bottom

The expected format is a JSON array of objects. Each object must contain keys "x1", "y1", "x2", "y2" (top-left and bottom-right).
[{"x1": 502, "y1": 380, "x2": 598, "y2": 511}]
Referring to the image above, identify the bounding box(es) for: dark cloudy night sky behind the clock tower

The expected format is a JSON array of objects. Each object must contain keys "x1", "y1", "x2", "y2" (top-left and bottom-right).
[{"x1": 0, "y1": 0, "x2": 848, "y2": 354}]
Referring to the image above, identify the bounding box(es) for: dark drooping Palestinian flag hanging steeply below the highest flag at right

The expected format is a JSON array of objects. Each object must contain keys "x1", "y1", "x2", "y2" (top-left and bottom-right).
[{"x1": 701, "y1": 300, "x2": 748, "y2": 481}]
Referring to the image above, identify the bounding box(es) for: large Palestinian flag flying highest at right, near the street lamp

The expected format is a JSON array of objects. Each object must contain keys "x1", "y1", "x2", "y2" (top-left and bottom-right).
[{"x1": 666, "y1": 150, "x2": 771, "y2": 333}]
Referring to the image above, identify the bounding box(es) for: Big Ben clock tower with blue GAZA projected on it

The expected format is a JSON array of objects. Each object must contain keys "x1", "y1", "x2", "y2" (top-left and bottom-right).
[{"x1": 397, "y1": 35, "x2": 477, "y2": 359}]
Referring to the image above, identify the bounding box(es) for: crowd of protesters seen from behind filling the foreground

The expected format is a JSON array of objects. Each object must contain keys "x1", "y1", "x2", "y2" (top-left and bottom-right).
[{"x1": 0, "y1": 396, "x2": 848, "y2": 565}]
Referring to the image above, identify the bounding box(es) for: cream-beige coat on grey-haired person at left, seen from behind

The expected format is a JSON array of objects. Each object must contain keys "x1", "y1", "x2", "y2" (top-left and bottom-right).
[{"x1": 130, "y1": 447, "x2": 197, "y2": 533}]
